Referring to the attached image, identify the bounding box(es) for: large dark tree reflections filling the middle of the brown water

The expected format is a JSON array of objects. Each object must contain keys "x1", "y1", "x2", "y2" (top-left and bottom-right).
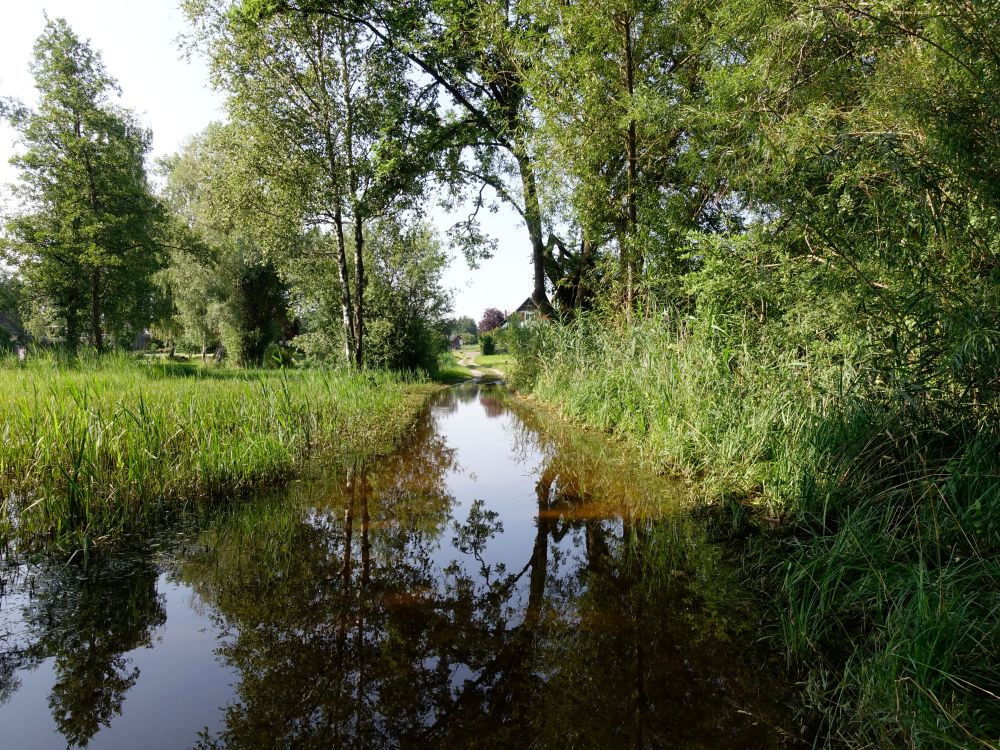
[{"x1": 186, "y1": 387, "x2": 796, "y2": 748}]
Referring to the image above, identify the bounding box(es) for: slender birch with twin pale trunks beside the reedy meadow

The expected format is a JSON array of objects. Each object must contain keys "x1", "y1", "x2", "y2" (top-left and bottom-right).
[{"x1": 185, "y1": 0, "x2": 436, "y2": 367}]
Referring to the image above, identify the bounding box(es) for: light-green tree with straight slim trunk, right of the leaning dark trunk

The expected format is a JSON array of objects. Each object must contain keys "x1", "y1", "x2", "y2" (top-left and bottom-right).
[{"x1": 525, "y1": 0, "x2": 718, "y2": 310}]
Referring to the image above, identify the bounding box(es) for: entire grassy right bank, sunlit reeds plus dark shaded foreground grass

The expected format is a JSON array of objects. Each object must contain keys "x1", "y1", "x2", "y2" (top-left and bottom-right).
[{"x1": 513, "y1": 320, "x2": 1000, "y2": 748}]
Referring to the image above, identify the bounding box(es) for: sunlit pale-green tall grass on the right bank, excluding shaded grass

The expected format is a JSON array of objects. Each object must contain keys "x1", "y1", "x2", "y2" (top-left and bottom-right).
[{"x1": 511, "y1": 318, "x2": 854, "y2": 511}]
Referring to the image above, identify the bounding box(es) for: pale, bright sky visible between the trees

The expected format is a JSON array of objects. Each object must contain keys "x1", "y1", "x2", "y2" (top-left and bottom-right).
[{"x1": 0, "y1": 0, "x2": 531, "y2": 320}]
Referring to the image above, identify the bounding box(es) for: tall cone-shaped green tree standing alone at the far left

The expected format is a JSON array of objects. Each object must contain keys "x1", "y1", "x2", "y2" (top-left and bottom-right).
[{"x1": 2, "y1": 19, "x2": 161, "y2": 351}]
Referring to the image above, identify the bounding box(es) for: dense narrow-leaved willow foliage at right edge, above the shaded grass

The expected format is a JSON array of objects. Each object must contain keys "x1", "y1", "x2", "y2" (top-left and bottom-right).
[{"x1": 697, "y1": 0, "x2": 1000, "y2": 407}]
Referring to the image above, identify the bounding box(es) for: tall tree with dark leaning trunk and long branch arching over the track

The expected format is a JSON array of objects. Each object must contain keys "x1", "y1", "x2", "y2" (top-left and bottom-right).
[{"x1": 236, "y1": 0, "x2": 570, "y2": 312}]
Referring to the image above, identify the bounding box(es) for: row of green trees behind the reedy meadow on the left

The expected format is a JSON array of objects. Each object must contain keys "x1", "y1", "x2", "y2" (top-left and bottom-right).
[{"x1": 0, "y1": 19, "x2": 450, "y2": 371}]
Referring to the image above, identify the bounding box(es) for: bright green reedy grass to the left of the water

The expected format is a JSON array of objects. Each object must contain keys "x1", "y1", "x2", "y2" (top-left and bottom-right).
[{"x1": 0, "y1": 358, "x2": 434, "y2": 549}]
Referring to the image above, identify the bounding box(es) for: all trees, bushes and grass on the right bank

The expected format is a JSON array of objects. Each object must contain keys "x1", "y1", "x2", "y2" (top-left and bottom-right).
[{"x1": 500, "y1": 2, "x2": 1000, "y2": 748}]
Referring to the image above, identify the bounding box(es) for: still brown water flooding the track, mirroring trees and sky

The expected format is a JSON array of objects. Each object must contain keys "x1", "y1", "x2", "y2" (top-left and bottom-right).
[{"x1": 0, "y1": 385, "x2": 787, "y2": 748}]
